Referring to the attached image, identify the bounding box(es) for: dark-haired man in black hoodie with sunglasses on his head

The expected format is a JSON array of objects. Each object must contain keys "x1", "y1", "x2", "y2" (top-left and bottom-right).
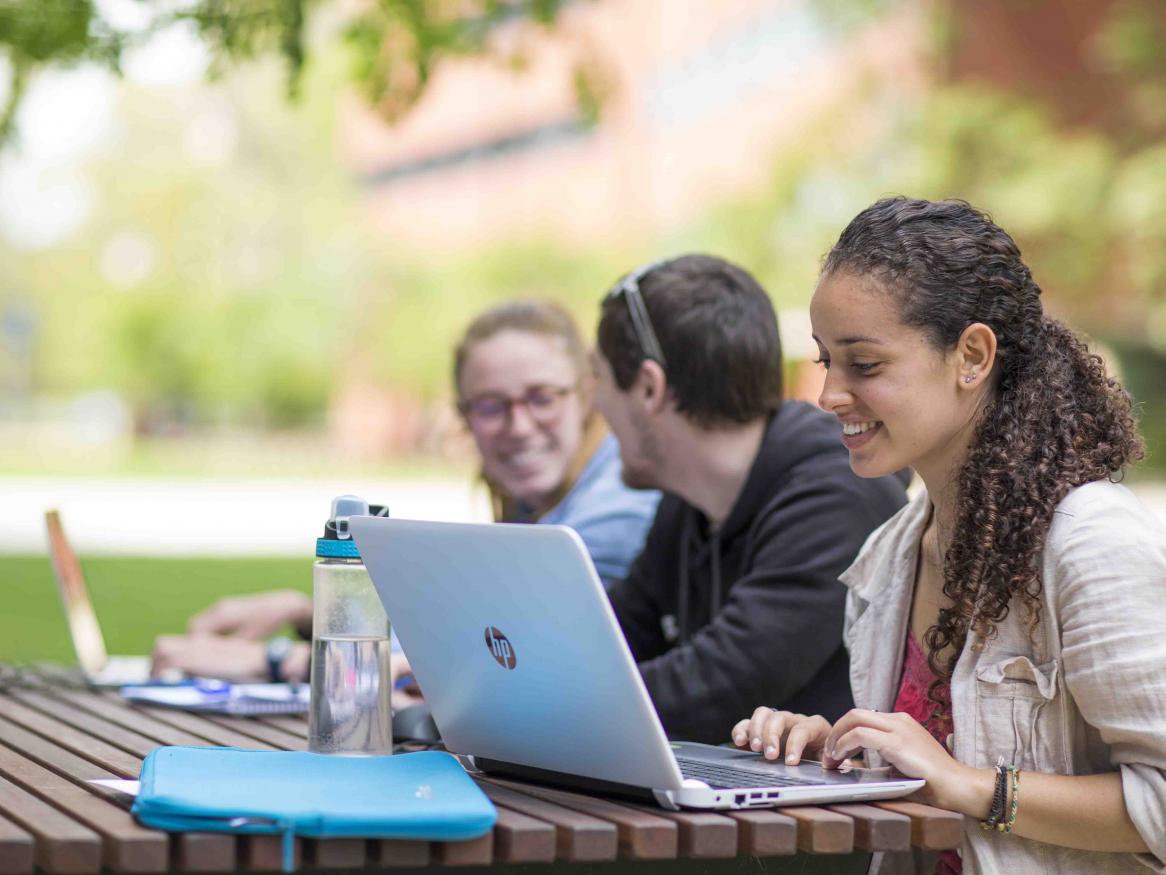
[{"x1": 592, "y1": 256, "x2": 906, "y2": 742}]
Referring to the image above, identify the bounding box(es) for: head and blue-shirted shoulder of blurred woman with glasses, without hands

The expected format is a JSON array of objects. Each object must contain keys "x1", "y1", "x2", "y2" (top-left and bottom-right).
[{"x1": 454, "y1": 301, "x2": 660, "y2": 586}]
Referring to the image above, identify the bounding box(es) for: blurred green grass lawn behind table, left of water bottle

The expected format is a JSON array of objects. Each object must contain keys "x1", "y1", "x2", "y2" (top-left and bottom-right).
[{"x1": 0, "y1": 555, "x2": 312, "y2": 663}]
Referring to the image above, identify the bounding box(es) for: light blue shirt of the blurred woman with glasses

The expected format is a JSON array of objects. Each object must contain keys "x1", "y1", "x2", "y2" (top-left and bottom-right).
[{"x1": 538, "y1": 434, "x2": 660, "y2": 589}]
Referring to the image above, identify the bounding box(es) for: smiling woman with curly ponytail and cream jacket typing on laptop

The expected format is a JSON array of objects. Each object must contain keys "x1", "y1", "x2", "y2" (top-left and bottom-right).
[{"x1": 732, "y1": 197, "x2": 1166, "y2": 873}]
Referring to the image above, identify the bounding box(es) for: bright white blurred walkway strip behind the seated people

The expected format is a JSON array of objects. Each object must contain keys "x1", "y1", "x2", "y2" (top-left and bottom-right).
[{"x1": 0, "y1": 478, "x2": 1166, "y2": 557}]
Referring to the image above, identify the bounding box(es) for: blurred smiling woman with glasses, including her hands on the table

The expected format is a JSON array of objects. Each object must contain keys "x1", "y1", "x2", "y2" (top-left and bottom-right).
[{"x1": 154, "y1": 301, "x2": 660, "y2": 686}]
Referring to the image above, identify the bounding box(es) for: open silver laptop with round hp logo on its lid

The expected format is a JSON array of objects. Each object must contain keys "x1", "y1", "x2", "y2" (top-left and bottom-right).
[{"x1": 351, "y1": 517, "x2": 923, "y2": 809}]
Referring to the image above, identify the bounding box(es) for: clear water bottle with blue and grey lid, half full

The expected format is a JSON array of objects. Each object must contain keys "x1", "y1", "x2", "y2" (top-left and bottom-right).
[{"x1": 308, "y1": 495, "x2": 393, "y2": 756}]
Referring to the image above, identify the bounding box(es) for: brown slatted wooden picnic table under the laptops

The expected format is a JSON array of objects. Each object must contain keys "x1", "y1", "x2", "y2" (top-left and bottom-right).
[{"x1": 0, "y1": 666, "x2": 962, "y2": 875}]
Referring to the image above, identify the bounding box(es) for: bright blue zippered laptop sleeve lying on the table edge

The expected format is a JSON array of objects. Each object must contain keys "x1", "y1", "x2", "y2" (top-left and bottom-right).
[{"x1": 132, "y1": 747, "x2": 497, "y2": 872}]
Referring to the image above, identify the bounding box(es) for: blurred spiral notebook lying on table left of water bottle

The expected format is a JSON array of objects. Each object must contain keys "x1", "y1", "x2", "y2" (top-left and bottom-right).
[{"x1": 121, "y1": 680, "x2": 311, "y2": 716}]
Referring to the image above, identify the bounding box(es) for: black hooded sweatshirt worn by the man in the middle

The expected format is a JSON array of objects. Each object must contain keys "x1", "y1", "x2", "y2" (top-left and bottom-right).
[{"x1": 610, "y1": 401, "x2": 906, "y2": 743}]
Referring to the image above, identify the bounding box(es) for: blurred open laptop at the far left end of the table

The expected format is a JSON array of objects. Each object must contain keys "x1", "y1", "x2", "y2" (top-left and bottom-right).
[{"x1": 44, "y1": 510, "x2": 158, "y2": 687}]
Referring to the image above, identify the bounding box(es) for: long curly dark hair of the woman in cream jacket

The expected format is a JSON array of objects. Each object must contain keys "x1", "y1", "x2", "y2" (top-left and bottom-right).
[{"x1": 822, "y1": 197, "x2": 1144, "y2": 711}]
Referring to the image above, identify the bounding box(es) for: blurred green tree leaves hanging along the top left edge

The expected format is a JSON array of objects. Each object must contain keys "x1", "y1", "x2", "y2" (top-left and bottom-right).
[{"x1": 0, "y1": 0, "x2": 578, "y2": 146}]
